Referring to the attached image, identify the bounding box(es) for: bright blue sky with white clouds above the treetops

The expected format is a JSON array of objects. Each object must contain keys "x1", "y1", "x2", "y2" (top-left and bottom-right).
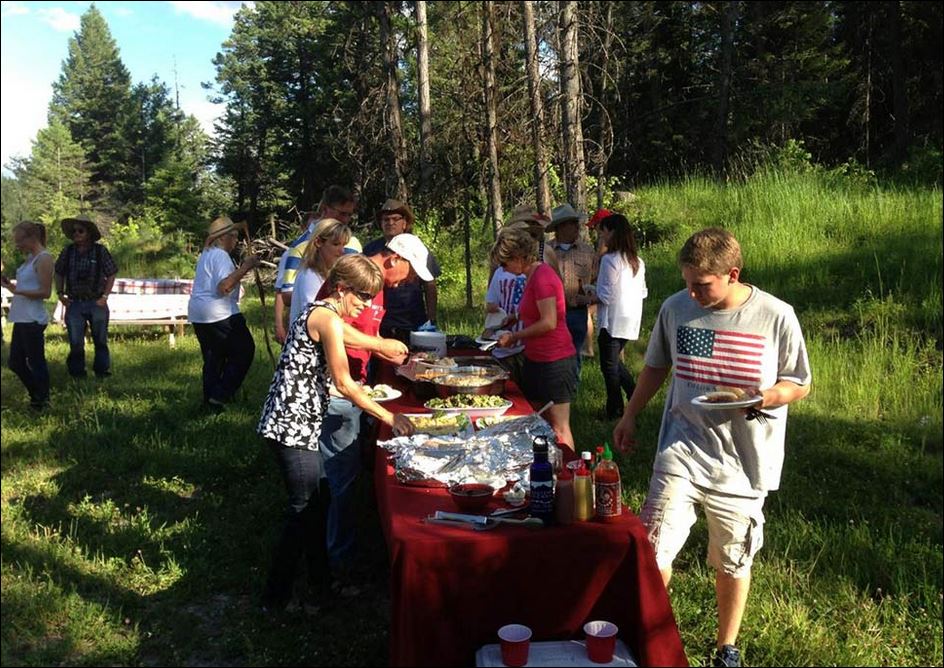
[{"x1": 0, "y1": 0, "x2": 243, "y2": 171}]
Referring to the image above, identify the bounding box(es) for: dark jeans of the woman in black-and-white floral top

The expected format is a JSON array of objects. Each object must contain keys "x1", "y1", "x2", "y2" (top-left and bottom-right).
[{"x1": 262, "y1": 438, "x2": 331, "y2": 608}]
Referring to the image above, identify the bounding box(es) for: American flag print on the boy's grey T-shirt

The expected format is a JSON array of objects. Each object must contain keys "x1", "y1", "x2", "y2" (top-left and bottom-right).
[{"x1": 675, "y1": 325, "x2": 764, "y2": 387}]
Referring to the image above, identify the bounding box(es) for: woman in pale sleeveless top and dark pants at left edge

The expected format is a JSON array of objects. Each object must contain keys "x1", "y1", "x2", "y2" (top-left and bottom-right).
[{"x1": 3, "y1": 221, "x2": 55, "y2": 411}]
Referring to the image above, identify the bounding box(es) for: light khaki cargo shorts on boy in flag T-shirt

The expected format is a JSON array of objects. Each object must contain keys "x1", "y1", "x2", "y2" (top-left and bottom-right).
[{"x1": 640, "y1": 471, "x2": 766, "y2": 578}]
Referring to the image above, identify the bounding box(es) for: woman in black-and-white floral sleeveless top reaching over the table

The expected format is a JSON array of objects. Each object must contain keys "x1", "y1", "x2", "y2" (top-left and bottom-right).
[{"x1": 257, "y1": 255, "x2": 413, "y2": 609}]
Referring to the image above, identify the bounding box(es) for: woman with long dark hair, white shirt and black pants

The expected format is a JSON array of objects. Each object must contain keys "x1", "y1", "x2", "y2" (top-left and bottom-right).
[{"x1": 595, "y1": 213, "x2": 648, "y2": 419}]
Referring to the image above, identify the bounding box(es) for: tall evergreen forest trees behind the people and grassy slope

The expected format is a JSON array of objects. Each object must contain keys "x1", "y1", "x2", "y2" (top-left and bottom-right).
[{"x1": 2, "y1": 2, "x2": 942, "y2": 276}]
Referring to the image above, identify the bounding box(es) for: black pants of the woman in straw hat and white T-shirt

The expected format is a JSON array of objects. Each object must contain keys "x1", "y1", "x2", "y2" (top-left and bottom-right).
[{"x1": 193, "y1": 313, "x2": 256, "y2": 402}]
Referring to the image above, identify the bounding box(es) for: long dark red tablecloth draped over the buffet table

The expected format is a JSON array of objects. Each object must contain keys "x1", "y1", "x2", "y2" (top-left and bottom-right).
[{"x1": 374, "y1": 358, "x2": 688, "y2": 666}]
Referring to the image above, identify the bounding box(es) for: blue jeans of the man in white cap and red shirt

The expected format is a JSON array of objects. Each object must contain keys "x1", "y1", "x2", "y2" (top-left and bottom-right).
[{"x1": 320, "y1": 397, "x2": 361, "y2": 569}]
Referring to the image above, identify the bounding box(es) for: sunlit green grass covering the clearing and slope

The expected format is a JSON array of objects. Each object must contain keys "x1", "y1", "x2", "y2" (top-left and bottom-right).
[{"x1": 0, "y1": 174, "x2": 944, "y2": 665}]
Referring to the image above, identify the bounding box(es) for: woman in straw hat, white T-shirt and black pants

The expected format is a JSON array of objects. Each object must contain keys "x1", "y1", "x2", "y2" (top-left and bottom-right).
[{"x1": 187, "y1": 216, "x2": 259, "y2": 411}]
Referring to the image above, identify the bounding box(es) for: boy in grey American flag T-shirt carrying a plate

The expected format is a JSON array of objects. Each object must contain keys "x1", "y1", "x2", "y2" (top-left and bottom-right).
[{"x1": 613, "y1": 228, "x2": 812, "y2": 666}]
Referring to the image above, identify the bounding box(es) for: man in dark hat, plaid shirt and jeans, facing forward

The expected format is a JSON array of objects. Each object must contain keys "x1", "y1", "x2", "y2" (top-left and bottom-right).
[{"x1": 55, "y1": 216, "x2": 118, "y2": 378}]
